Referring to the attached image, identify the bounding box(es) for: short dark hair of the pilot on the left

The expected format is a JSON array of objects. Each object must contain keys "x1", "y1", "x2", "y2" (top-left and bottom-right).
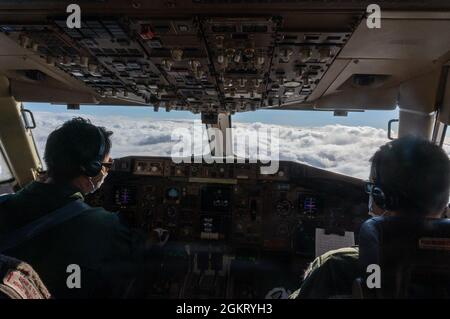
[{"x1": 44, "y1": 117, "x2": 112, "y2": 183}]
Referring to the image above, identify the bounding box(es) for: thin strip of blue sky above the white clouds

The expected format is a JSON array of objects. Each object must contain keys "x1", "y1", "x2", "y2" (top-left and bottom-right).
[{"x1": 25, "y1": 103, "x2": 398, "y2": 129}]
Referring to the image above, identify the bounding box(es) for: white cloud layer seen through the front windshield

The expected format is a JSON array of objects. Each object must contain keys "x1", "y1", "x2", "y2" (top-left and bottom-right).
[{"x1": 29, "y1": 112, "x2": 450, "y2": 179}]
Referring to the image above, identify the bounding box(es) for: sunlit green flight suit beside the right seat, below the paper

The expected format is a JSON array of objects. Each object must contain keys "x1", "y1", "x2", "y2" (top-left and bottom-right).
[{"x1": 289, "y1": 247, "x2": 360, "y2": 299}]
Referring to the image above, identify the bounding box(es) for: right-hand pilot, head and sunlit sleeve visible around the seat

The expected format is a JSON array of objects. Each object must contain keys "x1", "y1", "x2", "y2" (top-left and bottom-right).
[{"x1": 290, "y1": 136, "x2": 450, "y2": 299}]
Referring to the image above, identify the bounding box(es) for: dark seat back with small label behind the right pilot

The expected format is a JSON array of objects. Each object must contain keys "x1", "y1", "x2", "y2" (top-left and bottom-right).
[{"x1": 353, "y1": 217, "x2": 450, "y2": 299}]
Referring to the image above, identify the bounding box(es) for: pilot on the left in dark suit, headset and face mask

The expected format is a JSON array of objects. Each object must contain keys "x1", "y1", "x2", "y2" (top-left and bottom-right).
[{"x1": 0, "y1": 118, "x2": 151, "y2": 298}]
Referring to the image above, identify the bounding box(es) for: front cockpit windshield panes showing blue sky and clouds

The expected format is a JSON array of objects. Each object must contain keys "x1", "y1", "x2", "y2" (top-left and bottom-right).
[{"x1": 26, "y1": 103, "x2": 406, "y2": 179}]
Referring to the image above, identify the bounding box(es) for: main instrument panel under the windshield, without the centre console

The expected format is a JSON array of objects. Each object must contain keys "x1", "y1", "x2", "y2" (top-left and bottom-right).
[{"x1": 90, "y1": 157, "x2": 367, "y2": 256}]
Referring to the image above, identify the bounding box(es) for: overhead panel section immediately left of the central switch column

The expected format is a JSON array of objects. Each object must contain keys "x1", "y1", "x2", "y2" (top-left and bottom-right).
[{"x1": 131, "y1": 19, "x2": 220, "y2": 113}]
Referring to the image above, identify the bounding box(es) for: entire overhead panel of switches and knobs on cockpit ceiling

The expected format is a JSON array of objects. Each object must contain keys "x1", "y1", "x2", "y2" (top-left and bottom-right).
[{"x1": 0, "y1": 16, "x2": 351, "y2": 114}]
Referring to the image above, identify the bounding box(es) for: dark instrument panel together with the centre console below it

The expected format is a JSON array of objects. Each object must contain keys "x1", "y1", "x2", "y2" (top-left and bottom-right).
[{"x1": 87, "y1": 156, "x2": 367, "y2": 299}]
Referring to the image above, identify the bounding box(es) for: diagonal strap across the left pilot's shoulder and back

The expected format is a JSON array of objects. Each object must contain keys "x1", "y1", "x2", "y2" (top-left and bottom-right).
[{"x1": 0, "y1": 196, "x2": 91, "y2": 253}]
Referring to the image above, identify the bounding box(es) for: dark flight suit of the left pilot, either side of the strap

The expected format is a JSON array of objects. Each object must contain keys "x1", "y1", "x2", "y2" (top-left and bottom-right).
[{"x1": 0, "y1": 182, "x2": 146, "y2": 298}]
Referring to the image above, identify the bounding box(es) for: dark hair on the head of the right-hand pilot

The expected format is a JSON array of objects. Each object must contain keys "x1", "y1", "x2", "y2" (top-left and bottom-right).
[{"x1": 371, "y1": 136, "x2": 450, "y2": 217}]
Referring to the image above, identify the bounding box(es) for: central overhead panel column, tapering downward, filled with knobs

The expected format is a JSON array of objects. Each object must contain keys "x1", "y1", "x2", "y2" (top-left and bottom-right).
[{"x1": 202, "y1": 17, "x2": 278, "y2": 113}]
